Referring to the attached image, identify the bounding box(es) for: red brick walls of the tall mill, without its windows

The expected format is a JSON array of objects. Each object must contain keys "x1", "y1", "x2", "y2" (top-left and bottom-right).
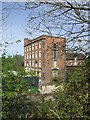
[{"x1": 24, "y1": 35, "x2": 65, "y2": 84}]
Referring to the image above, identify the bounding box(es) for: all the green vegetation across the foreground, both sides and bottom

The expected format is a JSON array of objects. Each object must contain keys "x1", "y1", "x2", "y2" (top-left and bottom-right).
[{"x1": 2, "y1": 56, "x2": 90, "y2": 120}]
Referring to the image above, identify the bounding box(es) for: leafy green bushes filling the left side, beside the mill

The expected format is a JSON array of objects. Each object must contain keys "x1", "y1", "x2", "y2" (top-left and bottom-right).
[{"x1": 2, "y1": 56, "x2": 37, "y2": 120}]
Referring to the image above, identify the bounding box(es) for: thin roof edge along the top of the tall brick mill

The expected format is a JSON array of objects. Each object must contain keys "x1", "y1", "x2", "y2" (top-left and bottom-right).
[{"x1": 24, "y1": 35, "x2": 65, "y2": 46}]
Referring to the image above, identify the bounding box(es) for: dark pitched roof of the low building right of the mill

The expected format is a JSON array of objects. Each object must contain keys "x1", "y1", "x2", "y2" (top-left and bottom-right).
[{"x1": 66, "y1": 53, "x2": 85, "y2": 60}]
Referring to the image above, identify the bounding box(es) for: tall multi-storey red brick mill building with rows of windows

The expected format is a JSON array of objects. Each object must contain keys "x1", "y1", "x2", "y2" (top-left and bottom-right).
[{"x1": 24, "y1": 35, "x2": 66, "y2": 84}]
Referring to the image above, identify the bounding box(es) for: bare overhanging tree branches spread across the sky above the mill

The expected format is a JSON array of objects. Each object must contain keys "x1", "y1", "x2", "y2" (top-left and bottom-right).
[{"x1": 25, "y1": 1, "x2": 90, "y2": 52}]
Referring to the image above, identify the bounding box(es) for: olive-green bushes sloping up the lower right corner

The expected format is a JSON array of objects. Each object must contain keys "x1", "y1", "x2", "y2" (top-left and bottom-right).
[{"x1": 38, "y1": 58, "x2": 90, "y2": 120}]
